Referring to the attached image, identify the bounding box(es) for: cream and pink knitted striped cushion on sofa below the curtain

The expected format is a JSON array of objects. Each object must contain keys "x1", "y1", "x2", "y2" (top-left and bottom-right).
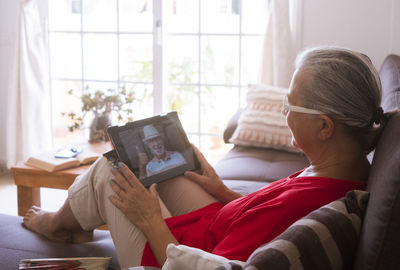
[{"x1": 229, "y1": 85, "x2": 299, "y2": 152}]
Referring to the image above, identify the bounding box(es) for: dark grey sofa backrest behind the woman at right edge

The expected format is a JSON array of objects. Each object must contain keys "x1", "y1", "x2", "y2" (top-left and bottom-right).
[{"x1": 355, "y1": 55, "x2": 400, "y2": 270}]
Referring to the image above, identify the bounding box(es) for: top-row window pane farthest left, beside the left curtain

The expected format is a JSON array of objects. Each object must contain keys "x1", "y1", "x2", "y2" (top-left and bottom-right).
[{"x1": 48, "y1": 0, "x2": 81, "y2": 31}]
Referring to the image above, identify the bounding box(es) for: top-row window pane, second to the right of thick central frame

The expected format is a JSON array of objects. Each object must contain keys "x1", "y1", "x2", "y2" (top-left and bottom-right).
[{"x1": 200, "y1": 0, "x2": 239, "y2": 33}]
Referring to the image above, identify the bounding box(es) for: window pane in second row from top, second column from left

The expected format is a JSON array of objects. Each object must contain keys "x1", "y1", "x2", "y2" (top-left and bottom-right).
[{"x1": 83, "y1": 34, "x2": 118, "y2": 80}]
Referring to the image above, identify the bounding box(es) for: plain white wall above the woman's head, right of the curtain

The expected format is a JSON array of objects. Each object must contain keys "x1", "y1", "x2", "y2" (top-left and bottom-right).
[{"x1": 301, "y1": 0, "x2": 400, "y2": 68}]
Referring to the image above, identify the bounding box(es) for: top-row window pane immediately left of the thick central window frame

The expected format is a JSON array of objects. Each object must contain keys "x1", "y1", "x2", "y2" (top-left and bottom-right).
[{"x1": 119, "y1": 0, "x2": 153, "y2": 32}]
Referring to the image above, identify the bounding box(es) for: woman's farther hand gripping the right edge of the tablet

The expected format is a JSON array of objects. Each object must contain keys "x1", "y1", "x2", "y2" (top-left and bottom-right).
[{"x1": 185, "y1": 145, "x2": 242, "y2": 204}]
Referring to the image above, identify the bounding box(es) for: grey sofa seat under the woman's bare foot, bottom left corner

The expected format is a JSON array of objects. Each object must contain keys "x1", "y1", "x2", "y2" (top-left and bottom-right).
[{"x1": 0, "y1": 214, "x2": 119, "y2": 270}]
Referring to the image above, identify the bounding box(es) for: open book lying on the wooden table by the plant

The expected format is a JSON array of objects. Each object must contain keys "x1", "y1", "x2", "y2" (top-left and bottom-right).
[{"x1": 25, "y1": 150, "x2": 100, "y2": 172}]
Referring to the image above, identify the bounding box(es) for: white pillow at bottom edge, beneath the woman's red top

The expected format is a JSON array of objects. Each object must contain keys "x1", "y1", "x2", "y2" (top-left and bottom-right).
[{"x1": 162, "y1": 244, "x2": 245, "y2": 270}]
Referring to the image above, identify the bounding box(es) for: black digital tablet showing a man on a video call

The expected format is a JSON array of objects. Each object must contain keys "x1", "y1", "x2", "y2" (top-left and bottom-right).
[{"x1": 107, "y1": 112, "x2": 200, "y2": 187}]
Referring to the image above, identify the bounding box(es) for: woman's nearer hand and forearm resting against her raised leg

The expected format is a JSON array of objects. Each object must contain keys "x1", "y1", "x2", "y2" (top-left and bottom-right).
[{"x1": 110, "y1": 163, "x2": 179, "y2": 267}]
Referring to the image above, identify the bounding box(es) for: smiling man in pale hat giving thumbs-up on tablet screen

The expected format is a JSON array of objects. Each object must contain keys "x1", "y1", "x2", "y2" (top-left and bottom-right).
[{"x1": 136, "y1": 125, "x2": 186, "y2": 178}]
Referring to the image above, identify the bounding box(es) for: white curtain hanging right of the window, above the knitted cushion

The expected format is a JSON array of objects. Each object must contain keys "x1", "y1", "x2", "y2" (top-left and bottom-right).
[{"x1": 260, "y1": 0, "x2": 296, "y2": 87}]
